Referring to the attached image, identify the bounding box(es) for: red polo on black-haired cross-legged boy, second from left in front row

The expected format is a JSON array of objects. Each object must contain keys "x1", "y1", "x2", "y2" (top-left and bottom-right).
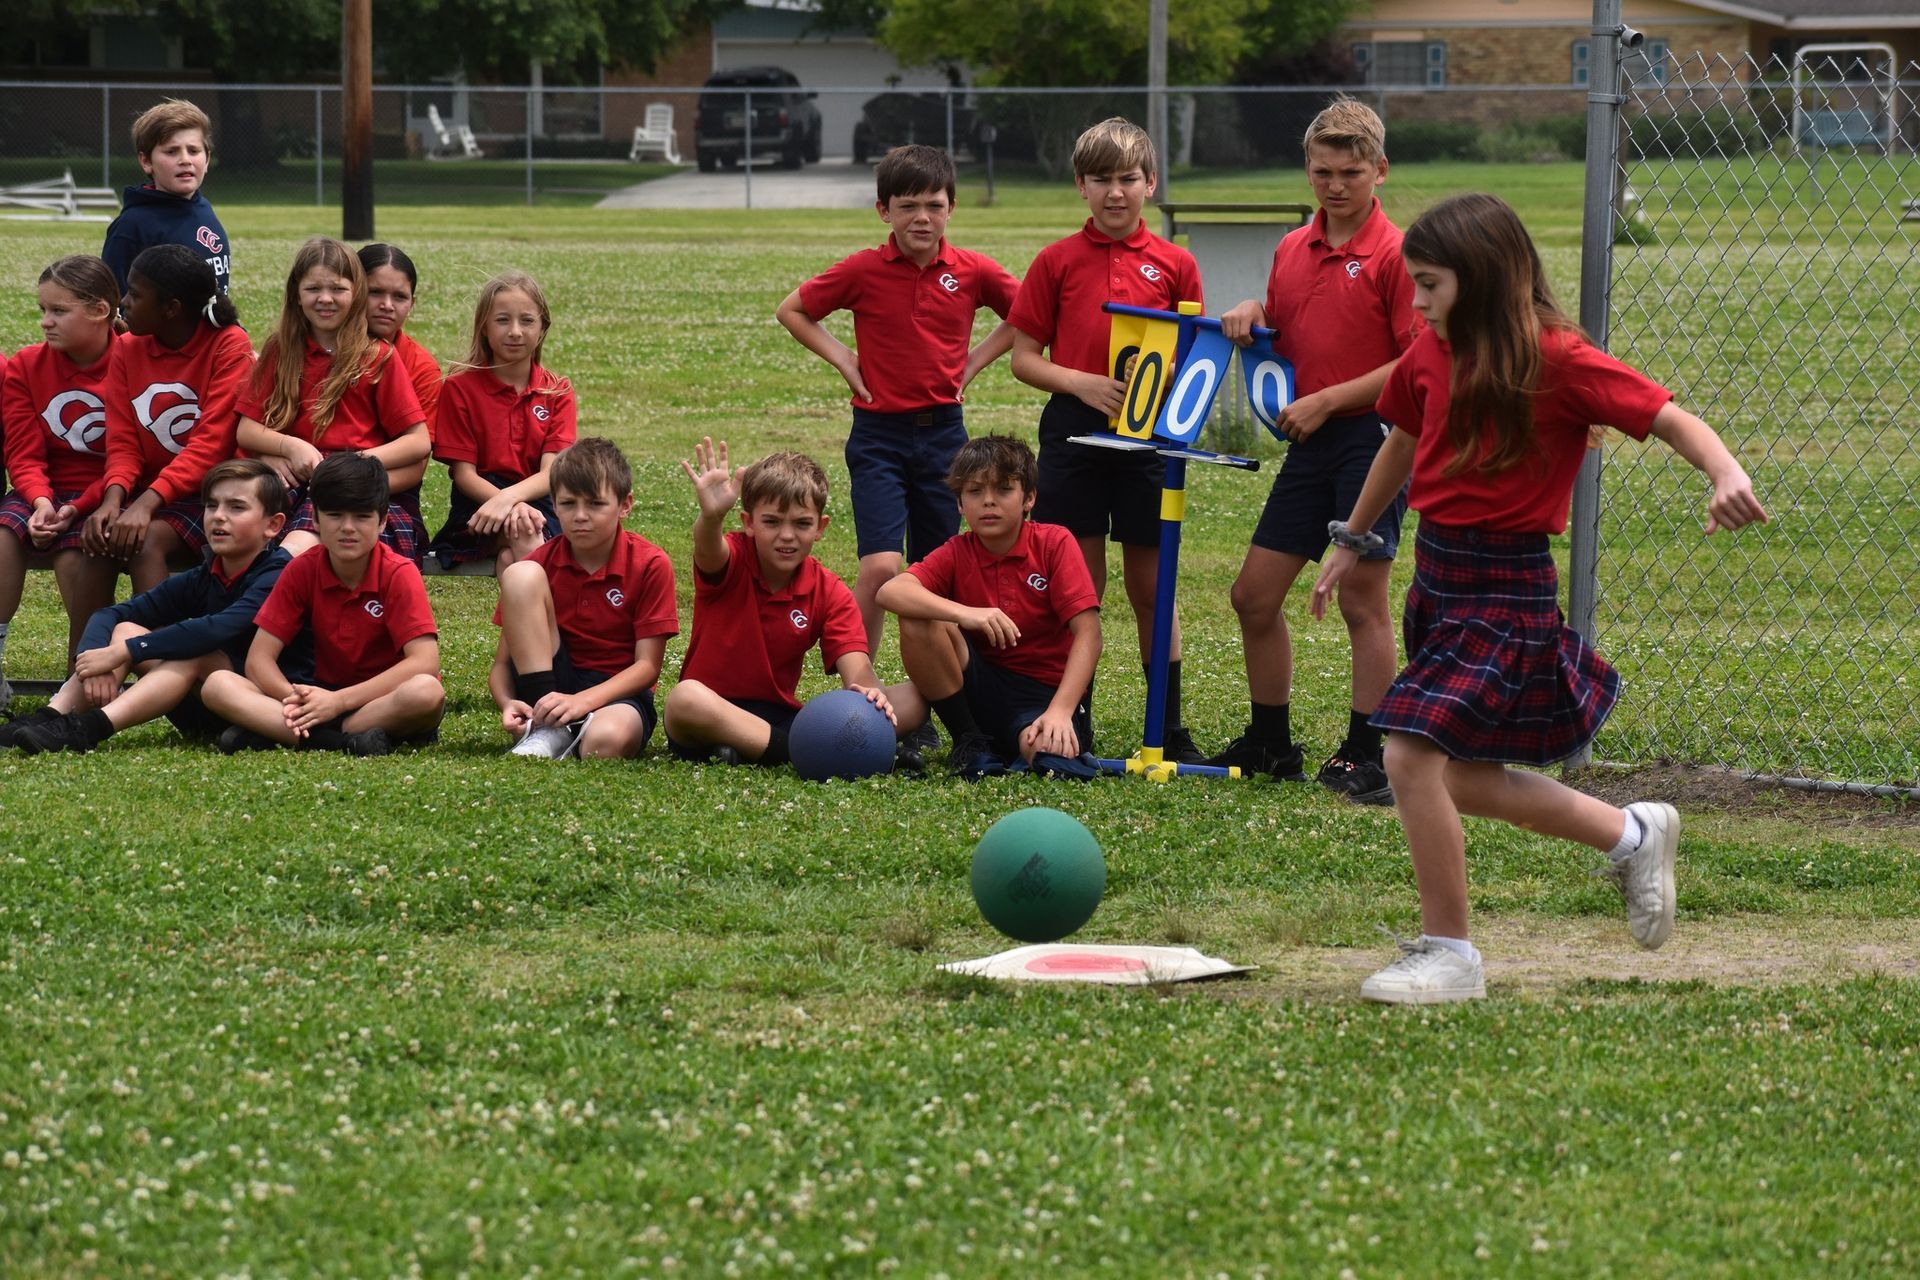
[{"x1": 253, "y1": 543, "x2": 440, "y2": 689}]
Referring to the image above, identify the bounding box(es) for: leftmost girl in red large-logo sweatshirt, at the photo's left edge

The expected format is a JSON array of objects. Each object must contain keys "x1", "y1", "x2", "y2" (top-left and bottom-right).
[{"x1": 0, "y1": 253, "x2": 121, "y2": 676}]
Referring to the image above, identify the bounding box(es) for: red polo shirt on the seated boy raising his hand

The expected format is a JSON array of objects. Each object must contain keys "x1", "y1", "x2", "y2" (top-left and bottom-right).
[{"x1": 680, "y1": 532, "x2": 866, "y2": 708}]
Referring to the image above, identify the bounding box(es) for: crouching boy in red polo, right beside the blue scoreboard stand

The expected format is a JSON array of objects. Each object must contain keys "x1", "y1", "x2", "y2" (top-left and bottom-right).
[{"x1": 879, "y1": 436, "x2": 1100, "y2": 781}]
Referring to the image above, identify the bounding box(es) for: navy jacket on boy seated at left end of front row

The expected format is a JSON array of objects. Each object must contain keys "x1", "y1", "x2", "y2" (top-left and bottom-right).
[{"x1": 81, "y1": 547, "x2": 292, "y2": 672}]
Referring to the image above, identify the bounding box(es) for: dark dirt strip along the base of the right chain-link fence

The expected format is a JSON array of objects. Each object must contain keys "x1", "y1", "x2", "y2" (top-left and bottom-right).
[{"x1": 1565, "y1": 764, "x2": 1920, "y2": 829}]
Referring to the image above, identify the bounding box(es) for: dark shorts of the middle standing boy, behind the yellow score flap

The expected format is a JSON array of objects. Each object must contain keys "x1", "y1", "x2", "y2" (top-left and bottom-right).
[{"x1": 1033, "y1": 395, "x2": 1159, "y2": 547}]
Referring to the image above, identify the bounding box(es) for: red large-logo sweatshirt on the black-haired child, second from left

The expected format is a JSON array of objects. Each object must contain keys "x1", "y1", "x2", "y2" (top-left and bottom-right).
[{"x1": 106, "y1": 322, "x2": 253, "y2": 503}]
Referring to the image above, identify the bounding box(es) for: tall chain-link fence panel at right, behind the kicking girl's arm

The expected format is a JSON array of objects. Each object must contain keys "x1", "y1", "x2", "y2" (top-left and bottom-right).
[{"x1": 1594, "y1": 46, "x2": 1920, "y2": 791}]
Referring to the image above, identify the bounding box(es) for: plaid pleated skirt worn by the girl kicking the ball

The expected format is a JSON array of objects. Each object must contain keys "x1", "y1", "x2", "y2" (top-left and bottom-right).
[{"x1": 1369, "y1": 522, "x2": 1620, "y2": 764}]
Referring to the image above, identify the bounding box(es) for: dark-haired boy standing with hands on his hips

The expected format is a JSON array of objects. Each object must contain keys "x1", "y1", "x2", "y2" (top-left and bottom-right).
[{"x1": 776, "y1": 144, "x2": 1020, "y2": 671}]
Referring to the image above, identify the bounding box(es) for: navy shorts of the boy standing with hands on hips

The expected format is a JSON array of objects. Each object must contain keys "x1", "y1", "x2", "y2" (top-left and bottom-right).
[{"x1": 847, "y1": 405, "x2": 966, "y2": 560}]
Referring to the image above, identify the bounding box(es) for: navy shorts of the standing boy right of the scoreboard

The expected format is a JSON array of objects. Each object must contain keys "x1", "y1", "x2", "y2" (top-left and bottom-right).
[{"x1": 1252, "y1": 413, "x2": 1407, "y2": 560}]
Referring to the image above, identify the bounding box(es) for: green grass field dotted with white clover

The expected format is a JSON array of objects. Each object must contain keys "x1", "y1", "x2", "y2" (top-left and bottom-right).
[{"x1": 0, "y1": 165, "x2": 1920, "y2": 1276}]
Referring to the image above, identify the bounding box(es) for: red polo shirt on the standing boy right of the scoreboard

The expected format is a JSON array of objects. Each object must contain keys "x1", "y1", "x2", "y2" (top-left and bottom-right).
[{"x1": 1265, "y1": 198, "x2": 1423, "y2": 395}]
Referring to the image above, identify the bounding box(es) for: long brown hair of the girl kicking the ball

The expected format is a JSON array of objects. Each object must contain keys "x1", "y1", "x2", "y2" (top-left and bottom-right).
[{"x1": 1400, "y1": 192, "x2": 1580, "y2": 476}]
